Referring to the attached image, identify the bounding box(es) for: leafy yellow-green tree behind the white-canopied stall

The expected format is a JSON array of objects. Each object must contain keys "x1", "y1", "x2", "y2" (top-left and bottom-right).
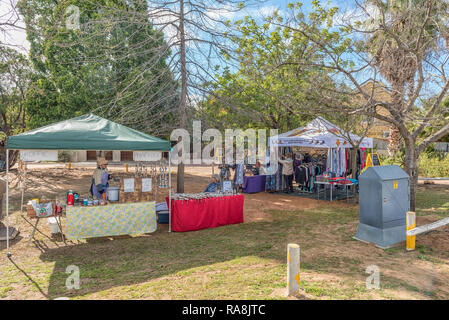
[{"x1": 201, "y1": 13, "x2": 324, "y2": 131}]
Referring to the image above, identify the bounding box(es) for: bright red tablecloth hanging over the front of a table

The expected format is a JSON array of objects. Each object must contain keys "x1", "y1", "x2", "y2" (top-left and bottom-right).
[{"x1": 165, "y1": 194, "x2": 244, "y2": 232}]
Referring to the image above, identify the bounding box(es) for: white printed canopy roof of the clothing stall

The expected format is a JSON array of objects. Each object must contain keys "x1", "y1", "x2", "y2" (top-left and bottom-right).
[{"x1": 268, "y1": 117, "x2": 373, "y2": 148}]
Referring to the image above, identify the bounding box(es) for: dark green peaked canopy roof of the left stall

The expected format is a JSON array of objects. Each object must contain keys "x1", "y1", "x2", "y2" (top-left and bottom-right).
[{"x1": 6, "y1": 114, "x2": 170, "y2": 151}]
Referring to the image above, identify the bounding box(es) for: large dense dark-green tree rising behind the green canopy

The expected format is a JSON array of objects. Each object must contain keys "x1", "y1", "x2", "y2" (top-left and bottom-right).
[{"x1": 20, "y1": 0, "x2": 177, "y2": 134}]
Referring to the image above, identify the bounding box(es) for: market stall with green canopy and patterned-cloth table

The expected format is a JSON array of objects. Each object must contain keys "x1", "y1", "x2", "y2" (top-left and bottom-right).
[{"x1": 6, "y1": 114, "x2": 171, "y2": 255}]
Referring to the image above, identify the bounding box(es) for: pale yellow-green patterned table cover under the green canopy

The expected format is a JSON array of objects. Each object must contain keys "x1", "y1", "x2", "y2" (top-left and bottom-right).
[{"x1": 66, "y1": 201, "x2": 157, "y2": 240}]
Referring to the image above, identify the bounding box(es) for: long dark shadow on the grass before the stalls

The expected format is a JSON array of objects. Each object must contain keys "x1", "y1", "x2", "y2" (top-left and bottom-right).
[{"x1": 31, "y1": 204, "x2": 354, "y2": 298}]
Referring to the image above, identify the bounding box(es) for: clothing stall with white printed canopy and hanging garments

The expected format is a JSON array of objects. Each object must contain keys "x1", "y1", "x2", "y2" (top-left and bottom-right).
[{"x1": 266, "y1": 117, "x2": 373, "y2": 200}]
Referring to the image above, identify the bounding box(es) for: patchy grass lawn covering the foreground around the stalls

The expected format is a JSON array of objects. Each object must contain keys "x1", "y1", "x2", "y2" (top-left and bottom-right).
[{"x1": 0, "y1": 169, "x2": 449, "y2": 299}]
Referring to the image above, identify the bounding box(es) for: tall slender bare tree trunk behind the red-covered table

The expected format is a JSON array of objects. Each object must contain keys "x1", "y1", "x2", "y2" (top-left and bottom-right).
[{"x1": 176, "y1": 0, "x2": 187, "y2": 193}]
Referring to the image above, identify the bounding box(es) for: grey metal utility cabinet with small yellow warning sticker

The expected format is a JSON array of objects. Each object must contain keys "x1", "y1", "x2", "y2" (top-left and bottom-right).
[{"x1": 355, "y1": 165, "x2": 410, "y2": 248}]
